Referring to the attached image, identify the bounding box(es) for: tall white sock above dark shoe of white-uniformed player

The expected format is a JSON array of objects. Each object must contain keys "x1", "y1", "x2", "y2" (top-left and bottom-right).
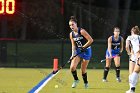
[{"x1": 130, "y1": 72, "x2": 139, "y2": 88}]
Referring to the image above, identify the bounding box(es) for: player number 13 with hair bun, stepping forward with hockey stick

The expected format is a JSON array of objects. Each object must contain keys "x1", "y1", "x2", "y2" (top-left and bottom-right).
[{"x1": 69, "y1": 16, "x2": 93, "y2": 88}]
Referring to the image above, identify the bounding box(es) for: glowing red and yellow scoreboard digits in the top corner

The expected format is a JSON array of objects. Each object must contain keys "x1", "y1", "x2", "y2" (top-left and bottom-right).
[{"x1": 0, "y1": 0, "x2": 15, "y2": 14}]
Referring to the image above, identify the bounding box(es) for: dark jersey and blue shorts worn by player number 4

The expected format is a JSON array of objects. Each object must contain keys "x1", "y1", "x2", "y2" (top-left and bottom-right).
[{"x1": 106, "y1": 35, "x2": 121, "y2": 57}]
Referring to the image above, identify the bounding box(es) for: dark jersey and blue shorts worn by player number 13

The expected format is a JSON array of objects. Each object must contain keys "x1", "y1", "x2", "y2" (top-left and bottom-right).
[{"x1": 72, "y1": 28, "x2": 92, "y2": 60}]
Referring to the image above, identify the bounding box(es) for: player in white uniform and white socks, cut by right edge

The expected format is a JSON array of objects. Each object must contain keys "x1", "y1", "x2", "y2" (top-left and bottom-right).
[{"x1": 126, "y1": 26, "x2": 140, "y2": 93}]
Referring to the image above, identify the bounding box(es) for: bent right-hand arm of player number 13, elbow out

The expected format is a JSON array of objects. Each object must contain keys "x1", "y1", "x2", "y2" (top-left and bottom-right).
[{"x1": 81, "y1": 29, "x2": 93, "y2": 48}]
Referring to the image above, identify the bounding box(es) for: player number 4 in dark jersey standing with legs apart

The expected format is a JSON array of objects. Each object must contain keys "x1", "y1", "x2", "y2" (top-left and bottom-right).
[{"x1": 103, "y1": 27, "x2": 124, "y2": 82}]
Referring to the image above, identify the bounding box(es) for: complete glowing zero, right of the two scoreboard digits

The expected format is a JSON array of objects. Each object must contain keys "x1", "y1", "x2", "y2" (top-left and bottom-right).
[{"x1": 6, "y1": 0, "x2": 15, "y2": 14}]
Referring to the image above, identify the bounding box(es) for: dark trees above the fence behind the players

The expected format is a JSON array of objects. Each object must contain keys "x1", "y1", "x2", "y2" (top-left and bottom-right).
[{"x1": 0, "y1": 0, "x2": 140, "y2": 40}]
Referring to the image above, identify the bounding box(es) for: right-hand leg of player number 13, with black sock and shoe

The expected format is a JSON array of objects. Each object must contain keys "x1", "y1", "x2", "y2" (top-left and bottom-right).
[{"x1": 81, "y1": 59, "x2": 89, "y2": 88}]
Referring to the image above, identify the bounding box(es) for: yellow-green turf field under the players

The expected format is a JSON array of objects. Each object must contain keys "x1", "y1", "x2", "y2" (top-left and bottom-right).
[{"x1": 0, "y1": 68, "x2": 140, "y2": 93}]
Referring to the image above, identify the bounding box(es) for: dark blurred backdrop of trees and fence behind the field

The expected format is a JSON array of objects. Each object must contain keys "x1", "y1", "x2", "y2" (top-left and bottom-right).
[{"x1": 0, "y1": 0, "x2": 140, "y2": 68}]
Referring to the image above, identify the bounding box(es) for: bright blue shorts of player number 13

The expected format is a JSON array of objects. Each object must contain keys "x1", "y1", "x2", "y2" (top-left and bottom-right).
[{"x1": 76, "y1": 47, "x2": 92, "y2": 60}]
